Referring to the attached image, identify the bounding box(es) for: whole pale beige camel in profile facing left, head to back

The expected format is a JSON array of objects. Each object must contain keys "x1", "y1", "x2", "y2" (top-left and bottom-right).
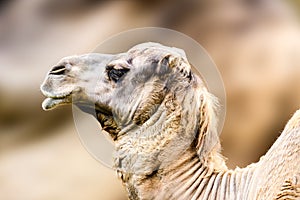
[{"x1": 41, "y1": 43, "x2": 300, "y2": 199}]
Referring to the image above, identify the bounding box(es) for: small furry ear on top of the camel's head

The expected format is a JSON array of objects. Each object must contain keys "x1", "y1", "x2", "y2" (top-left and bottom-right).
[{"x1": 160, "y1": 54, "x2": 192, "y2": 79}]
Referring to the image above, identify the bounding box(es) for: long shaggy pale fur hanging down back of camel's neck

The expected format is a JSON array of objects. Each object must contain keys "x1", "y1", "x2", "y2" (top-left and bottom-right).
[{"x1": 195, "y1": 84, "x2": 226, "y2": 170}]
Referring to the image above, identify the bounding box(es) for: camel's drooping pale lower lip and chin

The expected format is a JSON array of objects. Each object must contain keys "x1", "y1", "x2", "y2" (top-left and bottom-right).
[{"x1": 42, "y1": 93, "x2": 72, "y2": 111}]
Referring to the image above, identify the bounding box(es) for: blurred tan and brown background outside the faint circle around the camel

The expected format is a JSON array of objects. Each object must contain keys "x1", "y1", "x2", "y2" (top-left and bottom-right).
[{"x1": 0, "y1": 0, "x2": 300, "y2": 200}]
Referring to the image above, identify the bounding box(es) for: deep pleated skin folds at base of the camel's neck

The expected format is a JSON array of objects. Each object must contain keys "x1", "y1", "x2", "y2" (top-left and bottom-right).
[{"x1": 155, "y1": 150, "x2": 254, "y2": 200}]
